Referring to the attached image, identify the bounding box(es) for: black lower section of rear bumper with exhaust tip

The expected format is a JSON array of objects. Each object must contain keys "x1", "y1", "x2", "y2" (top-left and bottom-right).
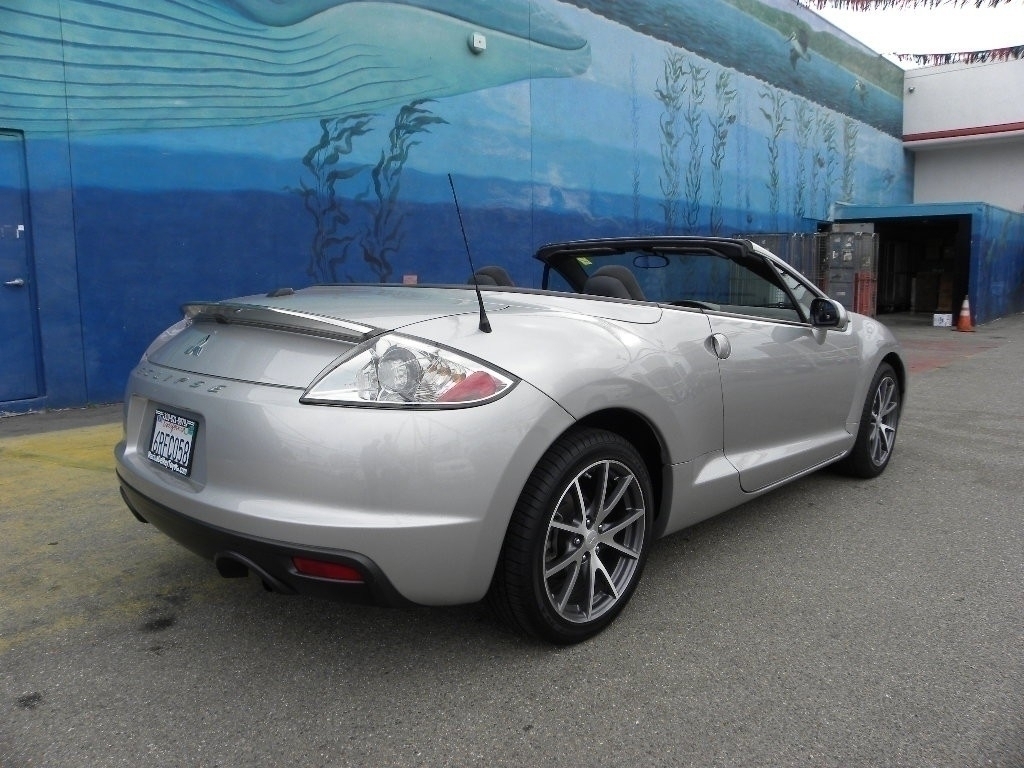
[{"x1": 118, "y1": 473, "x2": 411, "y2": 606}]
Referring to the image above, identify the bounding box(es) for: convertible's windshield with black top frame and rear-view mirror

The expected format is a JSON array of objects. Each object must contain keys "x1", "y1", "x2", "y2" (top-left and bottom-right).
[{"x1": 551, "y1": 247, "x2": 814, "y2": 322}]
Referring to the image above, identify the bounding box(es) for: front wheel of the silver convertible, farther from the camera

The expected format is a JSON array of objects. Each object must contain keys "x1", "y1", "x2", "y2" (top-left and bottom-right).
[{"x1": 839, "y1": 362, "x2": 901, "y2": 478}]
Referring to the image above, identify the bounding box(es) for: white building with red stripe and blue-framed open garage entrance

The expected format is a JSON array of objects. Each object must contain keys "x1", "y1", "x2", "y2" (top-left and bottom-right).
[{"x1": 836, "y1": 58, "x2": 1024, "y2": 323}]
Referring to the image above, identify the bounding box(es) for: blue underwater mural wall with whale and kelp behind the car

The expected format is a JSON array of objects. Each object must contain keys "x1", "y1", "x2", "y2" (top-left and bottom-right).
[{"x1": 0, "y1": 0, "x2": 913, "y2": 408}]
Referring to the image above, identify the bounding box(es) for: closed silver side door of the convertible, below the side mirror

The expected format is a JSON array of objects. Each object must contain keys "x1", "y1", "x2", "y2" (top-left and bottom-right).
[{"x1": 708, "y1": 254, "x2": 859, "y2": 492}]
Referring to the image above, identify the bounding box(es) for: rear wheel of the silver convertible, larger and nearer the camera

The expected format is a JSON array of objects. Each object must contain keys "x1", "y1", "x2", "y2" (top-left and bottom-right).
[{"x1": 488, "y1": 429, "x2": 653, "y2": 644}]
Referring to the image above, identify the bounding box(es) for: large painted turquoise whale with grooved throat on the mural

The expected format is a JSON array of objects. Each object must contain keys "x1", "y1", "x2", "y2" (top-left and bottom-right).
[{"x1": 0, "y1": 0, "x2": 591, "y2": 132}]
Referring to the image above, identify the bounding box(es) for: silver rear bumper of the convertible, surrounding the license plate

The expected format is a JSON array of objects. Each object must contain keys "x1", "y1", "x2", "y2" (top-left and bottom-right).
[{"x1": 115, "y1": 366, "x2": 572, "y2": 605}]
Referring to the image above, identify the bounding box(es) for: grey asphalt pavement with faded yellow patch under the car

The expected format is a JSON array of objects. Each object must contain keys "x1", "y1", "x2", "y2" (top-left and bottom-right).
[{"x1": 0, "y1": 315, "x2": 1024, "y2": 768}]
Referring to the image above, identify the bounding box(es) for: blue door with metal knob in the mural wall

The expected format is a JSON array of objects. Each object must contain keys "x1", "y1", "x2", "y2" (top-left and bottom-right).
[{"x1": 0, "y1": 130, "x2": 40, "y2": 401}]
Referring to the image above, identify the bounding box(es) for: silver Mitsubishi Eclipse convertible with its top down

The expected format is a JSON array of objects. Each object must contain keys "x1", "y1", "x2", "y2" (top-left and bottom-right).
[{"x1": 116, "y1": 238, "x2": 906, "y2": 643}]
